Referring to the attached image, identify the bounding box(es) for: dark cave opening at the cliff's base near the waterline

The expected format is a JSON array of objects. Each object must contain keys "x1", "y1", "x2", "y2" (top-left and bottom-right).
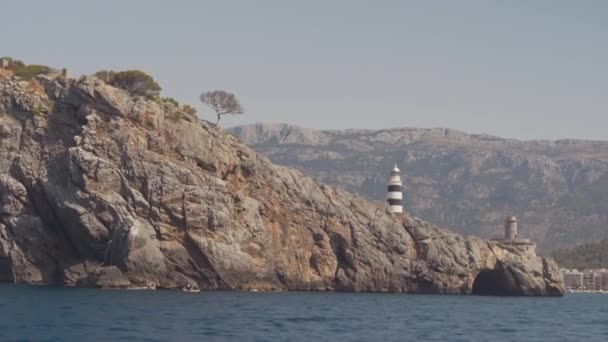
[{"x1": 472, "y1": 267, "x2": 522, "y2": 296}]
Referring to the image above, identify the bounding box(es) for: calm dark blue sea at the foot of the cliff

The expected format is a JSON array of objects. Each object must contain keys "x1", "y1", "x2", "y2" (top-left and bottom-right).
[{"x1": 0, "y1": 284, "x2": 608, "y2": 342}]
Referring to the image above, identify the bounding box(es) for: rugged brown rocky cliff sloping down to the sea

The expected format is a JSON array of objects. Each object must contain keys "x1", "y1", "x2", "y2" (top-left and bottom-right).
[{"x1": 0, "y1": 73, "x2": 563, "y2": 295}]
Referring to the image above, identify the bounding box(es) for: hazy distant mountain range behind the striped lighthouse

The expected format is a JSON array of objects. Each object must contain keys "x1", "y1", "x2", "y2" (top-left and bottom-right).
[{"x1": 232, "y1": 124, "x2": 608, "y2": 253}]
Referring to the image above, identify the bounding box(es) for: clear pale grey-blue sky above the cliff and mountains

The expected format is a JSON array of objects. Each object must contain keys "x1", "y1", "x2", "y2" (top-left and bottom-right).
[{"x1": 0, "y1": 0, "x2": 608, "y2": 139}]
